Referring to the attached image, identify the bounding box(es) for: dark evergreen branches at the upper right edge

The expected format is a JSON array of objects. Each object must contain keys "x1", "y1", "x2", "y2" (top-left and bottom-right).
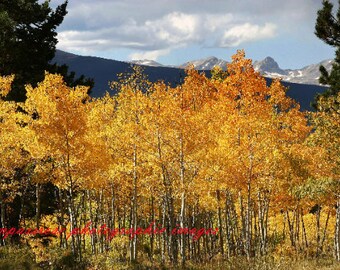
[{"x1": 315, "y1": 0, "x2": 340, "y2": 101}]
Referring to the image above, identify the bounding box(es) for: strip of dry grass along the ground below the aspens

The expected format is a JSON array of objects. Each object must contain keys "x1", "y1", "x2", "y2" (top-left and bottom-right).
[{"x1": 0, "y1": 246, "x2": 340, "y2": 270}]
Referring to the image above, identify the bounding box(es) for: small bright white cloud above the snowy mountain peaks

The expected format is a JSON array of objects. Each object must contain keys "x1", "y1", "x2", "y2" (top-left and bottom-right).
[{"x1": 219, "y1": 23, "x2": 276, "y2": 47}]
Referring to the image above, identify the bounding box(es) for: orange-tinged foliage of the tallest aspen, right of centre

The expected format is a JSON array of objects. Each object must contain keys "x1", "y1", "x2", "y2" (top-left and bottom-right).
[{"x1": 199, "y1": 51, "x2": 311, "y2": 207}]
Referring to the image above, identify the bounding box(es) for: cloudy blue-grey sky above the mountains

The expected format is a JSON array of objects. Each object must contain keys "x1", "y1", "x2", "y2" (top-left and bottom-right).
[{"x1": 51, "y1": 0, "x2": 337, "y2": 68}]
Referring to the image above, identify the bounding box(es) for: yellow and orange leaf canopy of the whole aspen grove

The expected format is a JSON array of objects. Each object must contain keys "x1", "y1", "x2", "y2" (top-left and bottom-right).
[{"x1": 0, "y1": 51, "x2": 332, "y2": 229}]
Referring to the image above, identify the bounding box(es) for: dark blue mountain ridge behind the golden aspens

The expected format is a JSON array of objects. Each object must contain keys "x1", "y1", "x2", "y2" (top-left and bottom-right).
[{"x1": 52, "y1": 50, "x2": 327, "y2": 110}]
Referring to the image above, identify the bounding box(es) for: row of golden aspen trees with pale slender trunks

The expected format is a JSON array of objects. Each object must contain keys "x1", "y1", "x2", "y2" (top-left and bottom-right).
[{"x1": 0, "y1": 51, "x2": 340, "y2": 265}]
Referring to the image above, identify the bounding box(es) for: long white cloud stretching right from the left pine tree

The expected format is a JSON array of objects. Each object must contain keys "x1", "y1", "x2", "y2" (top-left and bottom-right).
[{"x1": 58, "y1": 12, "x2": 203, "y2": 57}]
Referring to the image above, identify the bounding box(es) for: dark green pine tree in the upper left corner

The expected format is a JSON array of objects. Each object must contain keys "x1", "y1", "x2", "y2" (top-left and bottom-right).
[{"x1": 0, "y1": 0, "x2": 94, "y2": 101}]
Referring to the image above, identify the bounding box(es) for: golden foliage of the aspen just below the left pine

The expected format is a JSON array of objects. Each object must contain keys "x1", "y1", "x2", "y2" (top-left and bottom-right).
[{"x1": 25, "y1": 73, "x2": 90, "y2": 187}]
